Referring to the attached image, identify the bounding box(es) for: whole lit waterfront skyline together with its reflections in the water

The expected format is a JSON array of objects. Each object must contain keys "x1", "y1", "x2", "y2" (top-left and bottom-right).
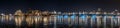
[{"x1": 0, "y1": 8, "x2": 120, "y2": 28}]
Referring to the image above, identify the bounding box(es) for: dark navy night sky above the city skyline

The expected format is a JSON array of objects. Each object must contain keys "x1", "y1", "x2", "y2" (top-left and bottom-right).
[{"x1": 0, "y1": 0, "x2": 120, "y2": 13}]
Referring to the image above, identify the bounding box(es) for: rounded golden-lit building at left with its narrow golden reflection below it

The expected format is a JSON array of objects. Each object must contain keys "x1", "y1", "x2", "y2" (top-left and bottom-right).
[{"x1": 14, "y1": 10, "x2": 24, "y2": 26}]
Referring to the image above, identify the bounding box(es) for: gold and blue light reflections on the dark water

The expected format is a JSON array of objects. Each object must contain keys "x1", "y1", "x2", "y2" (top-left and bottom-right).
[{"x1": 0, "y1": 15, "x2": 117, "y2": 27}]
